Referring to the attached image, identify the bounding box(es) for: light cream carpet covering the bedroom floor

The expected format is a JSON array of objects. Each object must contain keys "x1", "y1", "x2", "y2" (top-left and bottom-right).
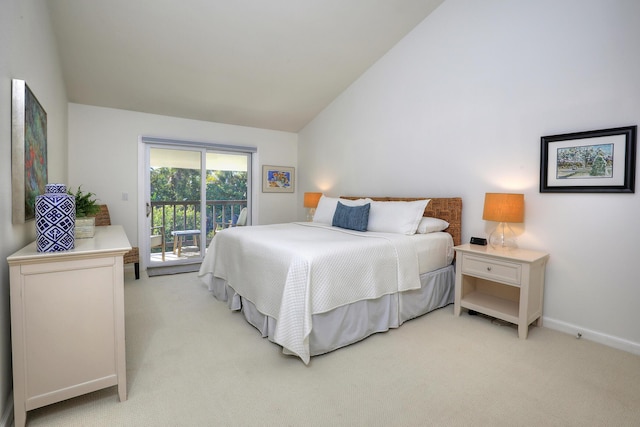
[{"x1": 27, "y1": 272, "x2": 640, "y2": 426}]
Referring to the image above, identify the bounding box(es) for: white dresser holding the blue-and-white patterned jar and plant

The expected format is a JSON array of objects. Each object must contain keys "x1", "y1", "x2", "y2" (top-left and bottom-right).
[{"x1": 7, "y1": 225, "x2": 131, "y2": 427}]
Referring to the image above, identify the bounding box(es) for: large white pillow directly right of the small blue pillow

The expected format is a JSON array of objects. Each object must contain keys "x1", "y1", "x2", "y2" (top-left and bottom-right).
[{"x1": 367, "y1": 199, "x2": 430, "y2": 235}]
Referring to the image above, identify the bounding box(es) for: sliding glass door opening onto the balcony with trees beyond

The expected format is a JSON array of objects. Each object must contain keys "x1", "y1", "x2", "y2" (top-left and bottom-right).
[{"x1": 140, "y1": 139, "x2": 251, "y2": 274}]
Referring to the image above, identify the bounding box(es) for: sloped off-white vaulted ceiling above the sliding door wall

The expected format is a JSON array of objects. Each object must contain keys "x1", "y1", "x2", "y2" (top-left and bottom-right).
[{"x1": 48, "y1": 0, "x2": 444, "y2": 132}]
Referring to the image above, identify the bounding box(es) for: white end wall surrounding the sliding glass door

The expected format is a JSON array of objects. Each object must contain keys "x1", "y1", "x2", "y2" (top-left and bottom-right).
[{"x1": 69, "y1": 104, "x2": 298, "y2": 246}]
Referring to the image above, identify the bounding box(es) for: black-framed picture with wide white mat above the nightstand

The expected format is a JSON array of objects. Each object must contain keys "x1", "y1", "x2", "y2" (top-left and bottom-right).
[{"x1": 540, "y1": 126, "x2": 638, "y2": 193}]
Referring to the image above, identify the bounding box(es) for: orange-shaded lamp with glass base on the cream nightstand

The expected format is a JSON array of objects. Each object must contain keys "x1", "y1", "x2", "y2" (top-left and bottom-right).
[{"x1": 482, "y1": 193, "x2": 524, "y2": 249}]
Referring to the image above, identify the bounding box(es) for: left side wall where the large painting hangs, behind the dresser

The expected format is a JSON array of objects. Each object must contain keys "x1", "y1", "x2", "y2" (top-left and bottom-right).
[{"x1": 0, "y1": 0, "x2": 67, "y2": 424}]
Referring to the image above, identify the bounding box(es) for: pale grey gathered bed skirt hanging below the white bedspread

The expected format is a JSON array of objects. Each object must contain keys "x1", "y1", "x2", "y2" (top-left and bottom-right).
[{"x1": 209, "y1": 265, "x2": 455, "y2": 362}]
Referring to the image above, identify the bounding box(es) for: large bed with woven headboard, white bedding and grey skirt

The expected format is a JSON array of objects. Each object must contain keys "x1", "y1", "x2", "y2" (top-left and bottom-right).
[{"x1": 198, "y1": 196, "x2": 462, "y2": 364}]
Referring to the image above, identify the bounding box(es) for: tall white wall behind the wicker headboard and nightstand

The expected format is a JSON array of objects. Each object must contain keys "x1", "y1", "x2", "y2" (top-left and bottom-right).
[{"x1": 298, "y1": 0, "x2": 640, "y2": 353}]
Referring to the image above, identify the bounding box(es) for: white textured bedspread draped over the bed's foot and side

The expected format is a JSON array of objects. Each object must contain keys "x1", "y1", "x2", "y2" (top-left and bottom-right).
[{"x1": 199, "y1": 223, "x2": 432, "y2": 363}]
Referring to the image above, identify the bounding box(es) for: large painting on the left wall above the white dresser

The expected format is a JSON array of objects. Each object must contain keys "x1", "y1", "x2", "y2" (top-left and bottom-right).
[{"x1": 11, "y1": 79, "x2": 48, "y2": 224}]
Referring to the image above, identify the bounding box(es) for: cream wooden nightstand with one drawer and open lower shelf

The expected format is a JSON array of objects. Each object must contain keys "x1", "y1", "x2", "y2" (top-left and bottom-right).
[{"x1": 453, "y1": 244, "x2": 549, "y2": 339}]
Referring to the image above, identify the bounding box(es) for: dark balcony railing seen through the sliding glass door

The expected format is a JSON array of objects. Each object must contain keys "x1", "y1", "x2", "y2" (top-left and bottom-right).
[{"x1": 151, "y1": 200, "x2": 247, "y2": 250}]
